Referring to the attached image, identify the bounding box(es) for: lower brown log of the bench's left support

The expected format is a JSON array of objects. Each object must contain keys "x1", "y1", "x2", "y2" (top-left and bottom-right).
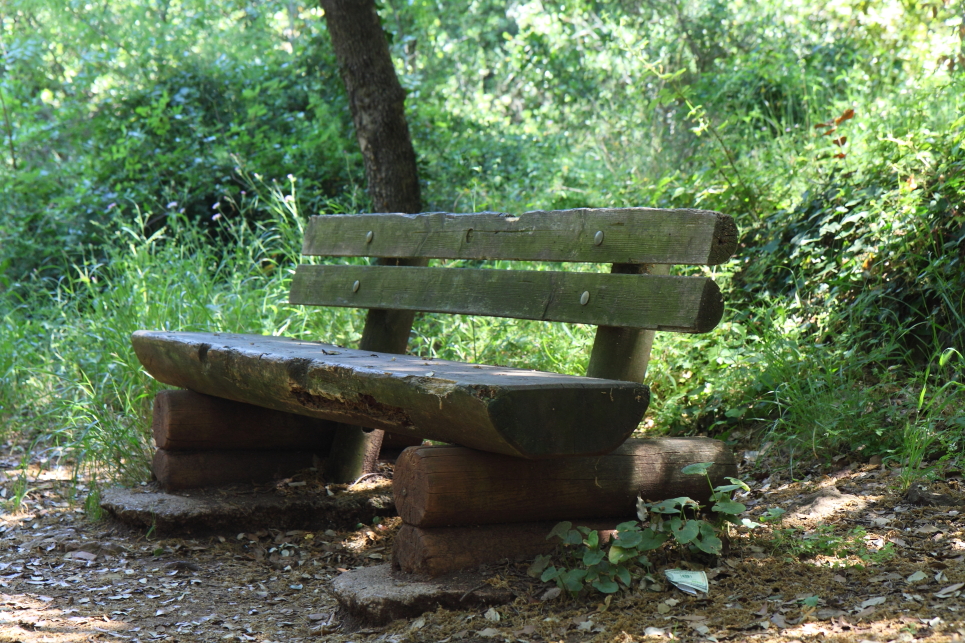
[{"x1": 153, "y1": 449, "x2": 316, "y2": 491}]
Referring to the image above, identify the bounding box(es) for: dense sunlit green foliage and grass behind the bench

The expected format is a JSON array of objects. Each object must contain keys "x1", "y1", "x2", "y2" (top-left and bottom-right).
[{"x1": 0, "y1": 0, "x2": 965, "y2": 484}]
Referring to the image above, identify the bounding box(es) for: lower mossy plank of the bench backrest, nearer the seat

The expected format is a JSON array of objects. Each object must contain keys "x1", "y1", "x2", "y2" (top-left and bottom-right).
[{"x1": 290, "y1": 265, "x2": 724, "y2": 333}]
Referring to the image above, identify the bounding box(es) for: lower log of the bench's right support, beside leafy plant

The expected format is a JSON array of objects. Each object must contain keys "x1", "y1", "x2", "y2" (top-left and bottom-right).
[{"x1": 392, "y1": 520, "x2": 616, "y2": 576}]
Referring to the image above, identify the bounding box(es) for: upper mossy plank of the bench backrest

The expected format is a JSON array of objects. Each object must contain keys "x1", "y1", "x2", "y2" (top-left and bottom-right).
[{"x1": 302, "y1": 208, "x2": 737, "y2": 265}]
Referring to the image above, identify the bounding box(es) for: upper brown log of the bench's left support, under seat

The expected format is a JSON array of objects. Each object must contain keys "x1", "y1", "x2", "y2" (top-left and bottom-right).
[{"x1": 152, "y1": 390, "x2": 335, "y2": 452}]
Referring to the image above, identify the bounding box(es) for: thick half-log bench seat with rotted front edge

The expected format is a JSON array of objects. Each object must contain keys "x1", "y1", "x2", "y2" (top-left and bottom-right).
[{"x1": 131, "y1": 331, "x2": 650, "y2": 459}]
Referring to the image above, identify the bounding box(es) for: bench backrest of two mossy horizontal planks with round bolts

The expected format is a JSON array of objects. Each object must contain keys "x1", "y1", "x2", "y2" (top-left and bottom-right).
[{"x1": 290, "y1": 208, "x2": 737, "y2": 379}]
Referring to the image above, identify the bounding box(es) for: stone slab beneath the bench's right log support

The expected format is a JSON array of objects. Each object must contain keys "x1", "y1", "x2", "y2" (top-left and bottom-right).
[{"x1": 332, "y1": 563, "x2": 513, "y2": 630}]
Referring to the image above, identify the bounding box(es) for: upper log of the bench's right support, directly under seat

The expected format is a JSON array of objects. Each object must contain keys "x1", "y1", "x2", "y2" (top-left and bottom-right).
[{"x1": 392, "y1": 438, "x2": 737, "y2": 527}]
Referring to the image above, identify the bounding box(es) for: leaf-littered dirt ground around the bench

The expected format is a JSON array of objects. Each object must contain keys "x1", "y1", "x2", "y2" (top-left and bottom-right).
[{"x1": 0, "y1": 442, "x2": 965, "y2": 643}]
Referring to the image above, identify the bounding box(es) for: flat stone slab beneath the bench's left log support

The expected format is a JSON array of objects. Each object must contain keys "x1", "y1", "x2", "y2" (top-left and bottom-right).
[{"x1": 101, "y1": 483, "x2": 396, "y2": 533}]
